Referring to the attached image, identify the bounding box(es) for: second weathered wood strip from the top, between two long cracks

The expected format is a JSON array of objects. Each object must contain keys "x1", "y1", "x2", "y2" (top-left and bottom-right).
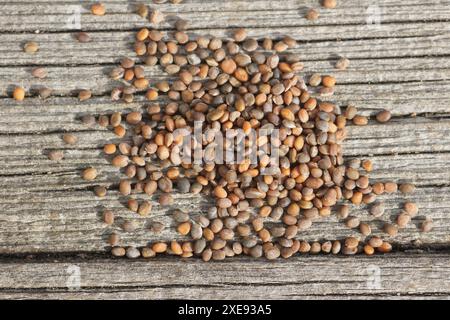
[{"x1": 0, "y1": 30, "x2": 450, "y2": 69}]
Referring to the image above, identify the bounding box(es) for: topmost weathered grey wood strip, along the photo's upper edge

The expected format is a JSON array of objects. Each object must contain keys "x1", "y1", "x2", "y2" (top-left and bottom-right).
[{"x1": 0, "y1": 0, "x2": 450, "y2": 32}]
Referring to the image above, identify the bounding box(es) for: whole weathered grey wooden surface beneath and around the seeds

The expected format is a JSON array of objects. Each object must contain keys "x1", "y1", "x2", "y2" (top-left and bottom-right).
[{"x1": 0, "y1": 0, "x2": 450, "y2": 298}]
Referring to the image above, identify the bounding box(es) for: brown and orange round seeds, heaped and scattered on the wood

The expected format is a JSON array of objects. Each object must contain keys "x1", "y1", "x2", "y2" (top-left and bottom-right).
[{"x1": 13, "y1": 1, "x2": 432, "y2": 261}]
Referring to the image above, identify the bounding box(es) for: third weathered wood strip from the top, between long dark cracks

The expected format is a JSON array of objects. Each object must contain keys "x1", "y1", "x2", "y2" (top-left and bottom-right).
[{"x1": 0, "y1": 57, "x2": 450, "y2": 96}]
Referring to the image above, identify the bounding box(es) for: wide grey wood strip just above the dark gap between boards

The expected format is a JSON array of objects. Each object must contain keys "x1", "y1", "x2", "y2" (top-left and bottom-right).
[{"x1": 0, "y1": 184, "x2": 450, "y2": 253}]
